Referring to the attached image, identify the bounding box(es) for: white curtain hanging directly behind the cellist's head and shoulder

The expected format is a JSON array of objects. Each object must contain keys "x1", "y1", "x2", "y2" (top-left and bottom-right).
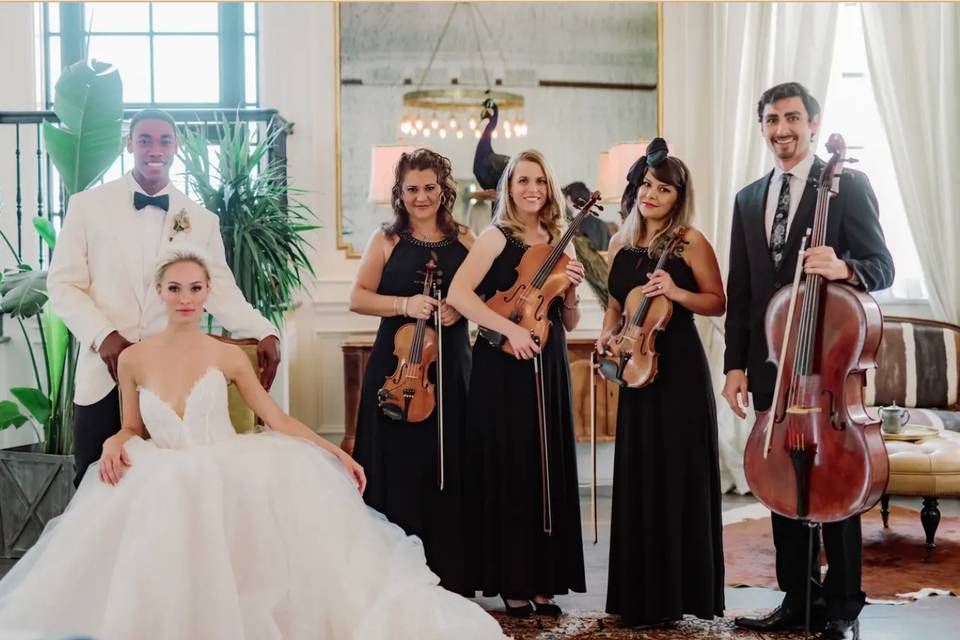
[{"x1": 662, "y1": 3, "x2": 837, "y2": 493}]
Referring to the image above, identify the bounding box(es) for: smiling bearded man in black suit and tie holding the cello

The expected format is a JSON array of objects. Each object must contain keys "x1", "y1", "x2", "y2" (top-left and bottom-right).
[{"x1": 723, "y1": 82, "x2": 893, "y2": 640}]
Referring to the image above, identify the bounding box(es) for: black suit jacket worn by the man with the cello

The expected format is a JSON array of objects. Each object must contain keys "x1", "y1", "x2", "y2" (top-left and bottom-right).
[{"x1": 723, "y1": 158, "x2": 893, "y2": 393}]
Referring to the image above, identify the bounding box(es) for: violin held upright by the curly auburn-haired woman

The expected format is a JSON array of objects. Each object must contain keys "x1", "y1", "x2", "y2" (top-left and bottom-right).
[{"x1": 377, "y1": 251, "x2": 442, "y2": 422}]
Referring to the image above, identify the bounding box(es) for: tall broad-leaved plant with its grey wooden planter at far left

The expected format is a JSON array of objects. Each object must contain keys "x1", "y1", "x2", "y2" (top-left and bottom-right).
[{"x1": 0, "y1": 60, "x2": 123, "y2": 558}]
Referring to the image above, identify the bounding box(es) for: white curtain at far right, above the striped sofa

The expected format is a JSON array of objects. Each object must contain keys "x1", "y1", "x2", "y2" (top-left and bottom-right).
[{"x1": 861, "y1": 3, "x2": 960, "y2": 323}]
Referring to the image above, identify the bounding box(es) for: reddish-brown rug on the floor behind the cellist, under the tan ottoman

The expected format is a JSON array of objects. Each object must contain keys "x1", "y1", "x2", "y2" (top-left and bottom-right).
[{"x1": 723, "y1": 498, "x2": 960, "y2": 600}]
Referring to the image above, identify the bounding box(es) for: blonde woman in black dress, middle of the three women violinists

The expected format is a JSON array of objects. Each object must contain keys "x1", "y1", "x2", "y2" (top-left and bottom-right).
[{"x1": 450, "y1": 151, "x2": 586, "y2": 616}]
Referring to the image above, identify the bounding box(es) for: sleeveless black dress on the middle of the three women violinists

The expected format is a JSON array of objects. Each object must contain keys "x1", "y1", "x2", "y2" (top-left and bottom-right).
[{"x1": 467, "y1": 229, "x2": 586, "y2": 599}]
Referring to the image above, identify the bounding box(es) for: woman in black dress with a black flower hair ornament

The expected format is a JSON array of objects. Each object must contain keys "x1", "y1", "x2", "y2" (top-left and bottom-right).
[{"x1": 597, "y1": 138, "x2": 726, "y2": 626}]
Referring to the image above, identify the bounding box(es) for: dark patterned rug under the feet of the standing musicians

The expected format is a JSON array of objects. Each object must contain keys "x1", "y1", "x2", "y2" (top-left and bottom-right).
[{"x1": 490, "y1": 610, "x2": 807, "y2": 640}]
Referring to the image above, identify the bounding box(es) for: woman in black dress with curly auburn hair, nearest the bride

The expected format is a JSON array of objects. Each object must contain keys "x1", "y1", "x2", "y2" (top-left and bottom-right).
[{"x1": 350, "y1": 149, "x2": 474, "y2": 595}]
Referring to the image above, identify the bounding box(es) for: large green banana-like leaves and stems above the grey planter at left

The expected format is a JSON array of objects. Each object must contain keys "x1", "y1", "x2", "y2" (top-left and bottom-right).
[{"x1": 0, "y1": 60, "x2": 123, "y2": 455}]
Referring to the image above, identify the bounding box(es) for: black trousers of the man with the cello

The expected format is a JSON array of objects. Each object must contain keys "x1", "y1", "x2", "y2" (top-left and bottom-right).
[{"x1": 753, "y1": 393, "x2": 866, "y2": 620}]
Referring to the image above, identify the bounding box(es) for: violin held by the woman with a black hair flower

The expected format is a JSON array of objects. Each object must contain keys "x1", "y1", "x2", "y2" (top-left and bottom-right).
[{"x1": 600, "y1": 227, "x2": 687, "y2": 389}]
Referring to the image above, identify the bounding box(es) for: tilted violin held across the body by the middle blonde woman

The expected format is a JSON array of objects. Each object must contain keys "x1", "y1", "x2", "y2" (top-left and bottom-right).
[{"x1": 478, "y1": 191, "x2": 600, "y2": 355}]
